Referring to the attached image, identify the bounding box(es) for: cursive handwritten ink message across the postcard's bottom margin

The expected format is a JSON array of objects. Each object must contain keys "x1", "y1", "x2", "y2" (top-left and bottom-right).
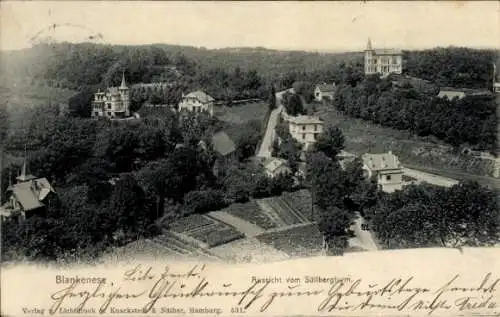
[{"x1": 13, "y1": 264, "x2": 500, "y2": 316}]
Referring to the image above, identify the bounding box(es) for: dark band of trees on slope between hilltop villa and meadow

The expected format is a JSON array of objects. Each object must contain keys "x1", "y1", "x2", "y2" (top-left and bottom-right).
[{"x1": 334, "y1": 76, "x2": 498, "y2": 152}]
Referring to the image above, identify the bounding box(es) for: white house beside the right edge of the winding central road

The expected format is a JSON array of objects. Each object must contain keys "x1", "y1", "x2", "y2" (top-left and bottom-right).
[{"x1": 287, "y1": 115, "x2": 324, "y2": 150}]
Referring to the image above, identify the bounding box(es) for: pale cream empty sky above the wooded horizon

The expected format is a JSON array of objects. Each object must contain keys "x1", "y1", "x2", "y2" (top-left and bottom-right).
[{"x1": 0, "y1": 1, "x2": 500, "y2": 51}]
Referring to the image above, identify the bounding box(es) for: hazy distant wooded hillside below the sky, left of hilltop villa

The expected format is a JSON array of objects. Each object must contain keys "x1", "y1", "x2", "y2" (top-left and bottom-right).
[{"x1": 2, "y1": 43, "x2": 361, "y2": 100}]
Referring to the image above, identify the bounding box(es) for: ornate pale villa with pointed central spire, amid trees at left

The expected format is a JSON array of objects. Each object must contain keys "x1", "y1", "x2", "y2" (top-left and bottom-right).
[{"x1": 92, "y1": 73, "x2": 130, "y2": 119}]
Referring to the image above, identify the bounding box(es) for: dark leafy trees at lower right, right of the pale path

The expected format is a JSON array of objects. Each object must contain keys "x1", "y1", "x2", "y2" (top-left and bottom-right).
[{"x1": 366, "y1": 182, "x2": 500, "y2": 249}]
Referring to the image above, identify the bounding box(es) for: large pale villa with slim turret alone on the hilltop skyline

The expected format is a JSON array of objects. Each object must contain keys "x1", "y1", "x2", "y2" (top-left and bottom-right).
[{"x1": 365, "y1": 39, "x2": 403, "y2": 77}]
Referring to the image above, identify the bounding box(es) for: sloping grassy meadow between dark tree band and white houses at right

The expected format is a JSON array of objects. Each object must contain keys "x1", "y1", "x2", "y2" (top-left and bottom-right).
[{"x1": 316, "y1": 101, "x2": 498, "y2": 186}]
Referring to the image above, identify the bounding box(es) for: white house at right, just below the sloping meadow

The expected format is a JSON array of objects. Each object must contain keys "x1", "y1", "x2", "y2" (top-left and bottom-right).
[{"x1": 362, "y1": 151, "x2": 403, "y2": 193}]
